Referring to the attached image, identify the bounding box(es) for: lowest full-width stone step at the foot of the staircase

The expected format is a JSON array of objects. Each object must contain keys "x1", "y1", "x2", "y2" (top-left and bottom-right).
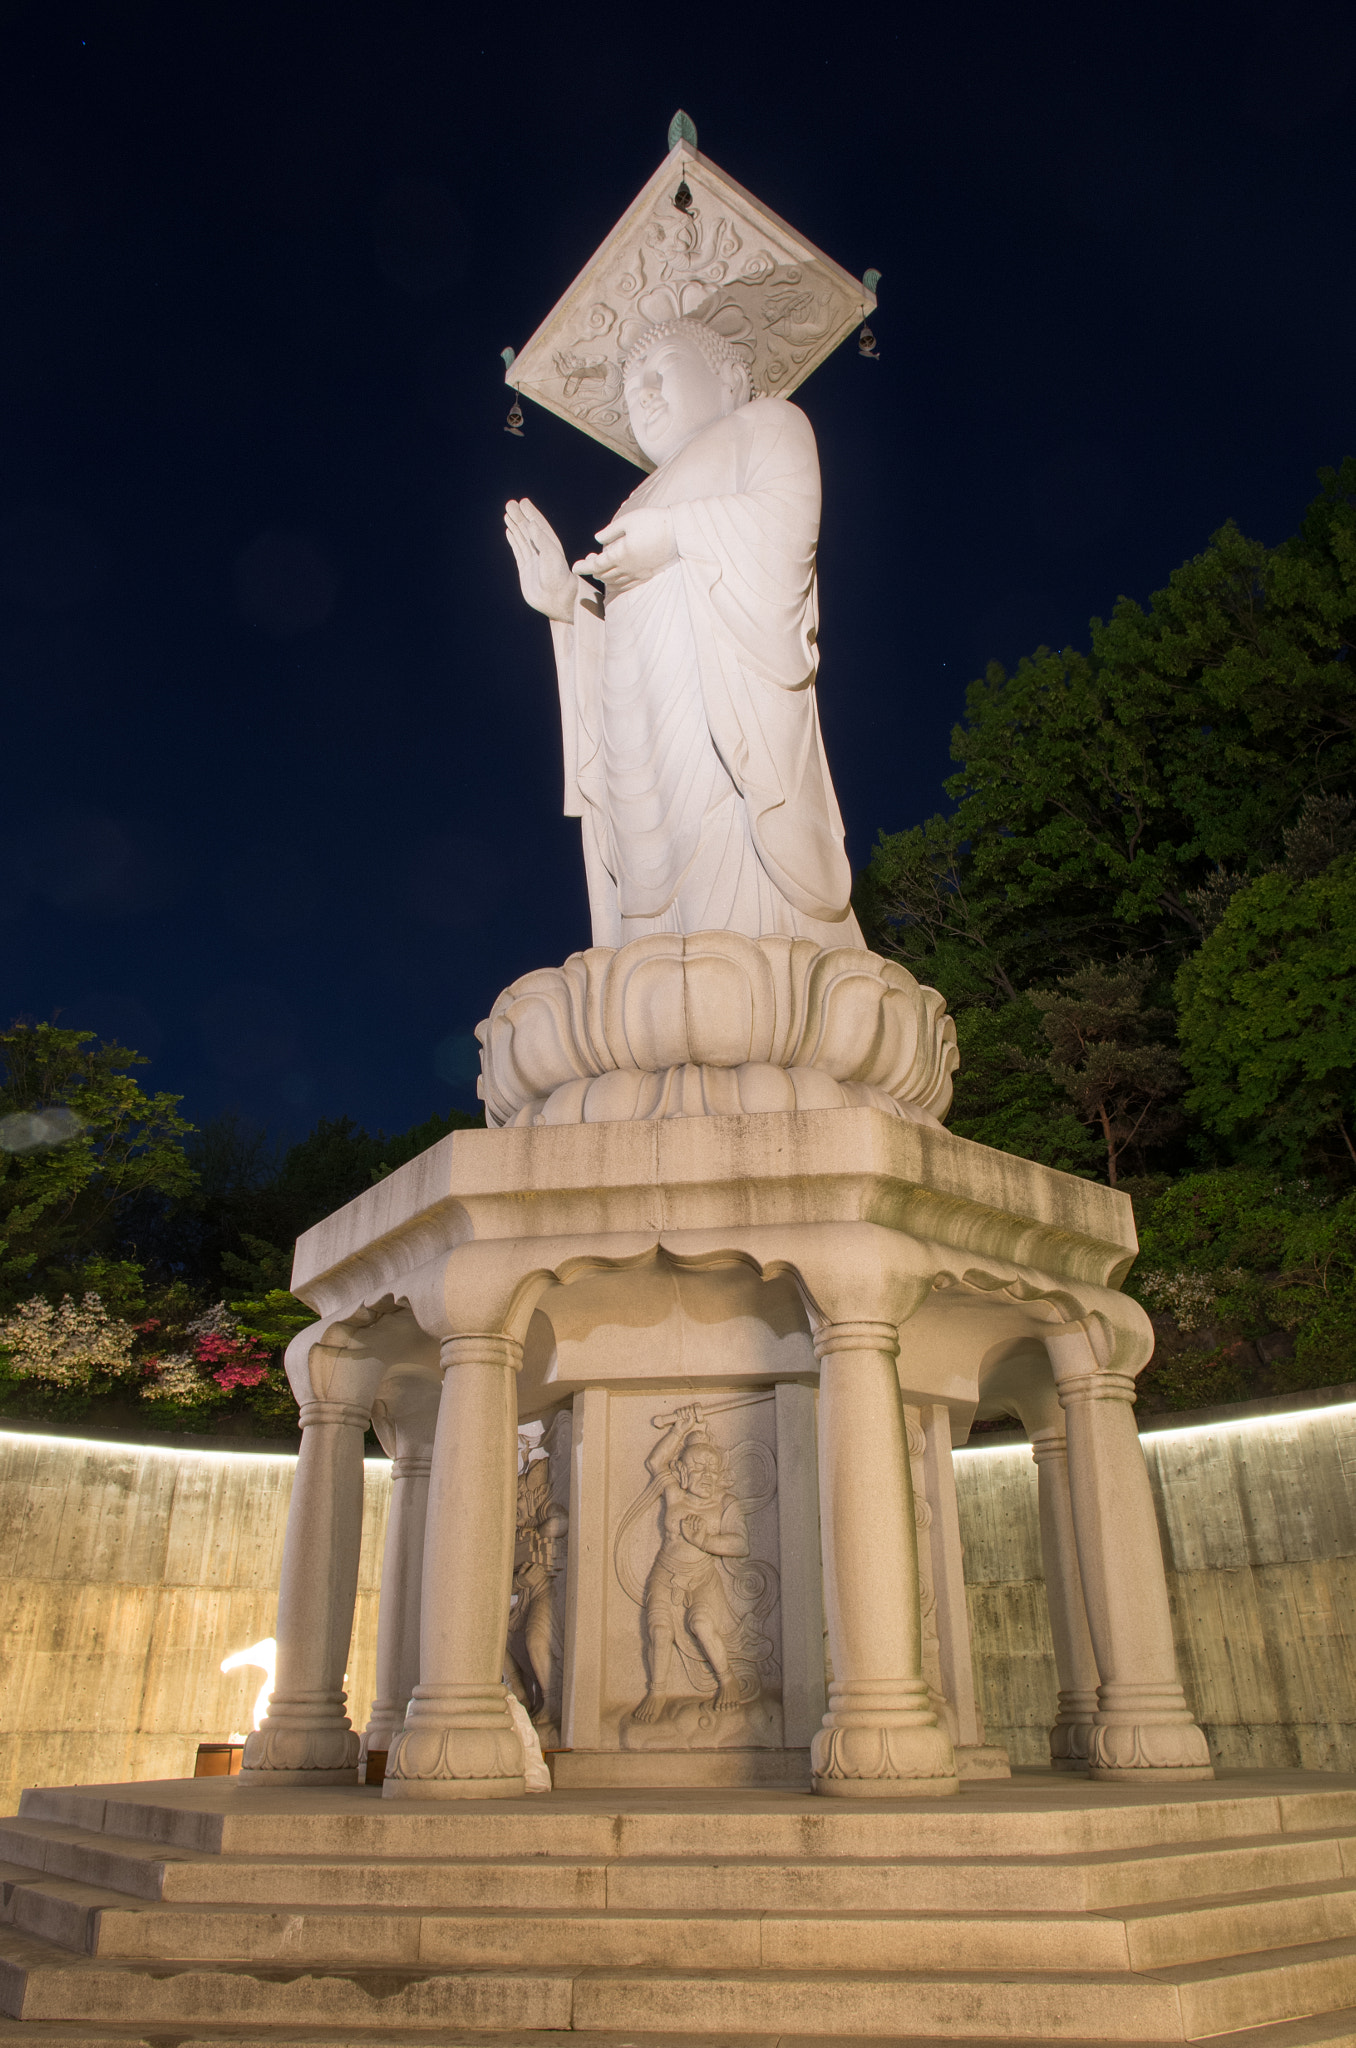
[{"x1": 0, "y1": 1931, "x2": 1356, "y2": 2048}]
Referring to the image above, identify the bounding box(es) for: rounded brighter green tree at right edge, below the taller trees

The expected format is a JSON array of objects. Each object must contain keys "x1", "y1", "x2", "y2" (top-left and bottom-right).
[{"x1": 1176, "y1": 854, "x2": 1356, "y2": 1171}]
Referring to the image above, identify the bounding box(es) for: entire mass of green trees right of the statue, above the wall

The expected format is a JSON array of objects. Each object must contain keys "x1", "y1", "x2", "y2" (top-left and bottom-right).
[{"x1": 856, "y1": 461, "x2": 1356, "y2": 1405}]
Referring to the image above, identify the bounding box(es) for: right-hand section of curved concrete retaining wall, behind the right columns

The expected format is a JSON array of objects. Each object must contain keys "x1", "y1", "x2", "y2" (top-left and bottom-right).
[{"x1": 957, "y1": 1403, "x2": 1356, "y2": 1772}]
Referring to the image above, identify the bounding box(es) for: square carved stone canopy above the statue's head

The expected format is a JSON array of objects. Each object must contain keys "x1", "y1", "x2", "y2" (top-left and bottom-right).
[{"x1": 504, "y1": 113, "x2": 877, "y2": 471}]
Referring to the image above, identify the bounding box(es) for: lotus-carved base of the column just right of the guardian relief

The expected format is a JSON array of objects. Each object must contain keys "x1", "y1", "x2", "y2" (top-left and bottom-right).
[{"x1": 809, "y1": 1686, "x2": 961, "y2": 1798}]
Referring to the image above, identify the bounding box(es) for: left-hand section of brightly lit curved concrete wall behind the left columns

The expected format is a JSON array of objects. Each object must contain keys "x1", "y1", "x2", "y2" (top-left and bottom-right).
[{"x1": 0, "y1": 1432, "x2": 391, "y2": 1812}]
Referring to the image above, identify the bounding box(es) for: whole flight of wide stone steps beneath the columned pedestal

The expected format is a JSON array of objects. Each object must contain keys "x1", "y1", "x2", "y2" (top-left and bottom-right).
[{"x1": 0, "y1": 1772, "x2": 1356, "y2": 2048}]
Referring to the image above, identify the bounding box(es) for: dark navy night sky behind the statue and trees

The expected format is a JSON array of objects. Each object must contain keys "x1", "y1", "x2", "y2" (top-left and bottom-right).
[{"x1": 0, "y1": 0, "x2": 1356, "y2": 1137}]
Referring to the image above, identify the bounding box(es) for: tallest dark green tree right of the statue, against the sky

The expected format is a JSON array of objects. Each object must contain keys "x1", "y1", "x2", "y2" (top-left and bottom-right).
[{"x1": 858, "y1": 461, "x2": 1356, "y2": 1001}]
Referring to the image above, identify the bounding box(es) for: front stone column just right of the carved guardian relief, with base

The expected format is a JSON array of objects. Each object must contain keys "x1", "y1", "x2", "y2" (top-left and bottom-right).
[{"x1": 809, "y1": 1323, "x2": 959, "y2": 1798}]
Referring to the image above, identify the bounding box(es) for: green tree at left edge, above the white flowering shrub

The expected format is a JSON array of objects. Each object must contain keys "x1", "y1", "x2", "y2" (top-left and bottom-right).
[{"x1": 0, "y1": 1022, "x2": 195, "y2": 1303}]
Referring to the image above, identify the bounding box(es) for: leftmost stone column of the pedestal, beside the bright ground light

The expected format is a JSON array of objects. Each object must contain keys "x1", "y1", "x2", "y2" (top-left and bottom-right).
[{"x1": 240, "y1": 1401, "x2": 369, "y2": 1786}]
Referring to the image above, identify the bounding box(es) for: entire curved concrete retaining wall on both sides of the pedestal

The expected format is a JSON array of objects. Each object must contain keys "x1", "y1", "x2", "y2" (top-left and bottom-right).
[{"x1": 0, "y1": 1403, "x2": 1356, "y2": 1812}]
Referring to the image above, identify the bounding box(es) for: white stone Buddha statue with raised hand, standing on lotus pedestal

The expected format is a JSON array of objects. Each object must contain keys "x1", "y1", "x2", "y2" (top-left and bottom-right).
[{"x1": 506, "y1": 317, "x2": 862, "y2": 946}]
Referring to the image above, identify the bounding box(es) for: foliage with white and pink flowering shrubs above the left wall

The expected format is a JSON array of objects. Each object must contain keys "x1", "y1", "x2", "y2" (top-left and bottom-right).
[{"x1": 0, "y1": 1040, "x2": 477, "y2": 1434}]
